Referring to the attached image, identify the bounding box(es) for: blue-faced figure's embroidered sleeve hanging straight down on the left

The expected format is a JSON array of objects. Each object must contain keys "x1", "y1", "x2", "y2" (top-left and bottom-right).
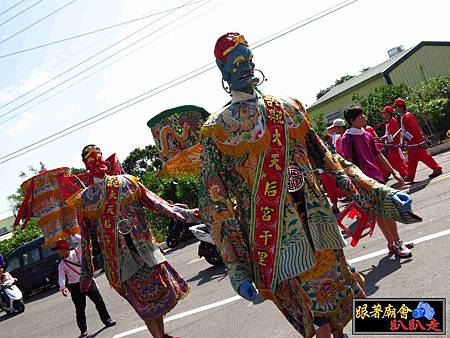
[{"x1": 199, "y1": 137, "x2": 253, "y2": 293}]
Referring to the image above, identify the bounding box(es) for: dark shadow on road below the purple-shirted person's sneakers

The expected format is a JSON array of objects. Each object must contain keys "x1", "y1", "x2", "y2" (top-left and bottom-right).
[{"x1": 359, "y1": 256, "x2": 412, "y2": 296}]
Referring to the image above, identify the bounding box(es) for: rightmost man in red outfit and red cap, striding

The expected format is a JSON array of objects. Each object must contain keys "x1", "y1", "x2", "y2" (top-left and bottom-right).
[{"x1": 394, "y1": 98, "x2": 442, "y2": 183}]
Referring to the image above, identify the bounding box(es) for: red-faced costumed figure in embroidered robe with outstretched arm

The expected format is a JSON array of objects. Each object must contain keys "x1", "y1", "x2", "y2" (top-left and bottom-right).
[{"x1": 68, "y1": 145, "x2": 198, "y2": 338}]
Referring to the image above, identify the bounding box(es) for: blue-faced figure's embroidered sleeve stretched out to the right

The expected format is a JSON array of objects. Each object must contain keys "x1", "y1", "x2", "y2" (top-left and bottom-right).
[{"x1": 306, "y1": 129, "x2": 421, "y2": 223}]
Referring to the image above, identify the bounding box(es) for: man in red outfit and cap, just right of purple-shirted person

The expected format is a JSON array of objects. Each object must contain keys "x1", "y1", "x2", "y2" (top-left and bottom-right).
[{"x1": 381, "y1": 106, "x2": 408, "y2": 178}]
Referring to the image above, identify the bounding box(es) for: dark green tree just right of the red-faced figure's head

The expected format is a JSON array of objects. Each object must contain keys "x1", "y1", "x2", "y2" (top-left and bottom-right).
[{"x1": 122, "y1": 145, "x2": 162, "y2": 177}]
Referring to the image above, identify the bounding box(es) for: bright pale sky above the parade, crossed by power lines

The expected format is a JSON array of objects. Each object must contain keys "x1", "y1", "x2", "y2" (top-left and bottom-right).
[{"x1": 0, "y1": 0, "x2": 450, "y2": 218}]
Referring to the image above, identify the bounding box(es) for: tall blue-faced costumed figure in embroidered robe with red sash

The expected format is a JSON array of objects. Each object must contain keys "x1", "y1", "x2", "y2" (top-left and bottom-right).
[{"x1": 200, "y1": 33, "x2": 419, "y2": 337}]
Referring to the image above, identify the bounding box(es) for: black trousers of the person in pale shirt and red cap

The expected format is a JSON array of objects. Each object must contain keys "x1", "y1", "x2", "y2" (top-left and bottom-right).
[{"x1": 67, "y1": 282, "x2": 111, "y2": 332}]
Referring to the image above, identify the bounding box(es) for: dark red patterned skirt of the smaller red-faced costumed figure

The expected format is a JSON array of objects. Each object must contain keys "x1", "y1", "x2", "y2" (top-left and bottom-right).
[{"x1": 120, "y1": 262, "x2": 189, "y2": 321}]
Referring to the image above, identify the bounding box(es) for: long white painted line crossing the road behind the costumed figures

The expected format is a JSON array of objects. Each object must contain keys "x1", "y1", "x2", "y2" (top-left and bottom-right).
[{"x1": 113, "y1": 229, "x2": 450, "y2": 338}]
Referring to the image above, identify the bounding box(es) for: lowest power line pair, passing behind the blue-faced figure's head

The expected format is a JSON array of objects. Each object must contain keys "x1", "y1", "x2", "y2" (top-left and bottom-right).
[{"x1": 0, "y1": 0, "x2": 359, "y2": 164}]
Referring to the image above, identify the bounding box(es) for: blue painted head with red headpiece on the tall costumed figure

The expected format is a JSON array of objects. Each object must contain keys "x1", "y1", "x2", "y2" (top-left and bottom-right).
[{"x1": 214, "y1": 33, "x2": 259, "y2": 92}]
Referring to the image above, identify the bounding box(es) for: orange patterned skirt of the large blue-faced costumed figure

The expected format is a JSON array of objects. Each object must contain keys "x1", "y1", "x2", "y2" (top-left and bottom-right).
[{"x1": 275, "y1": 250, "x2": 365, "y2": 338}]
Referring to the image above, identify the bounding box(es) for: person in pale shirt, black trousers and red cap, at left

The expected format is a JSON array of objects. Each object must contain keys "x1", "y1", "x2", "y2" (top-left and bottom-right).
[{"x1": 52, "y1": 235, "x2": 116, "y2": 337}]
